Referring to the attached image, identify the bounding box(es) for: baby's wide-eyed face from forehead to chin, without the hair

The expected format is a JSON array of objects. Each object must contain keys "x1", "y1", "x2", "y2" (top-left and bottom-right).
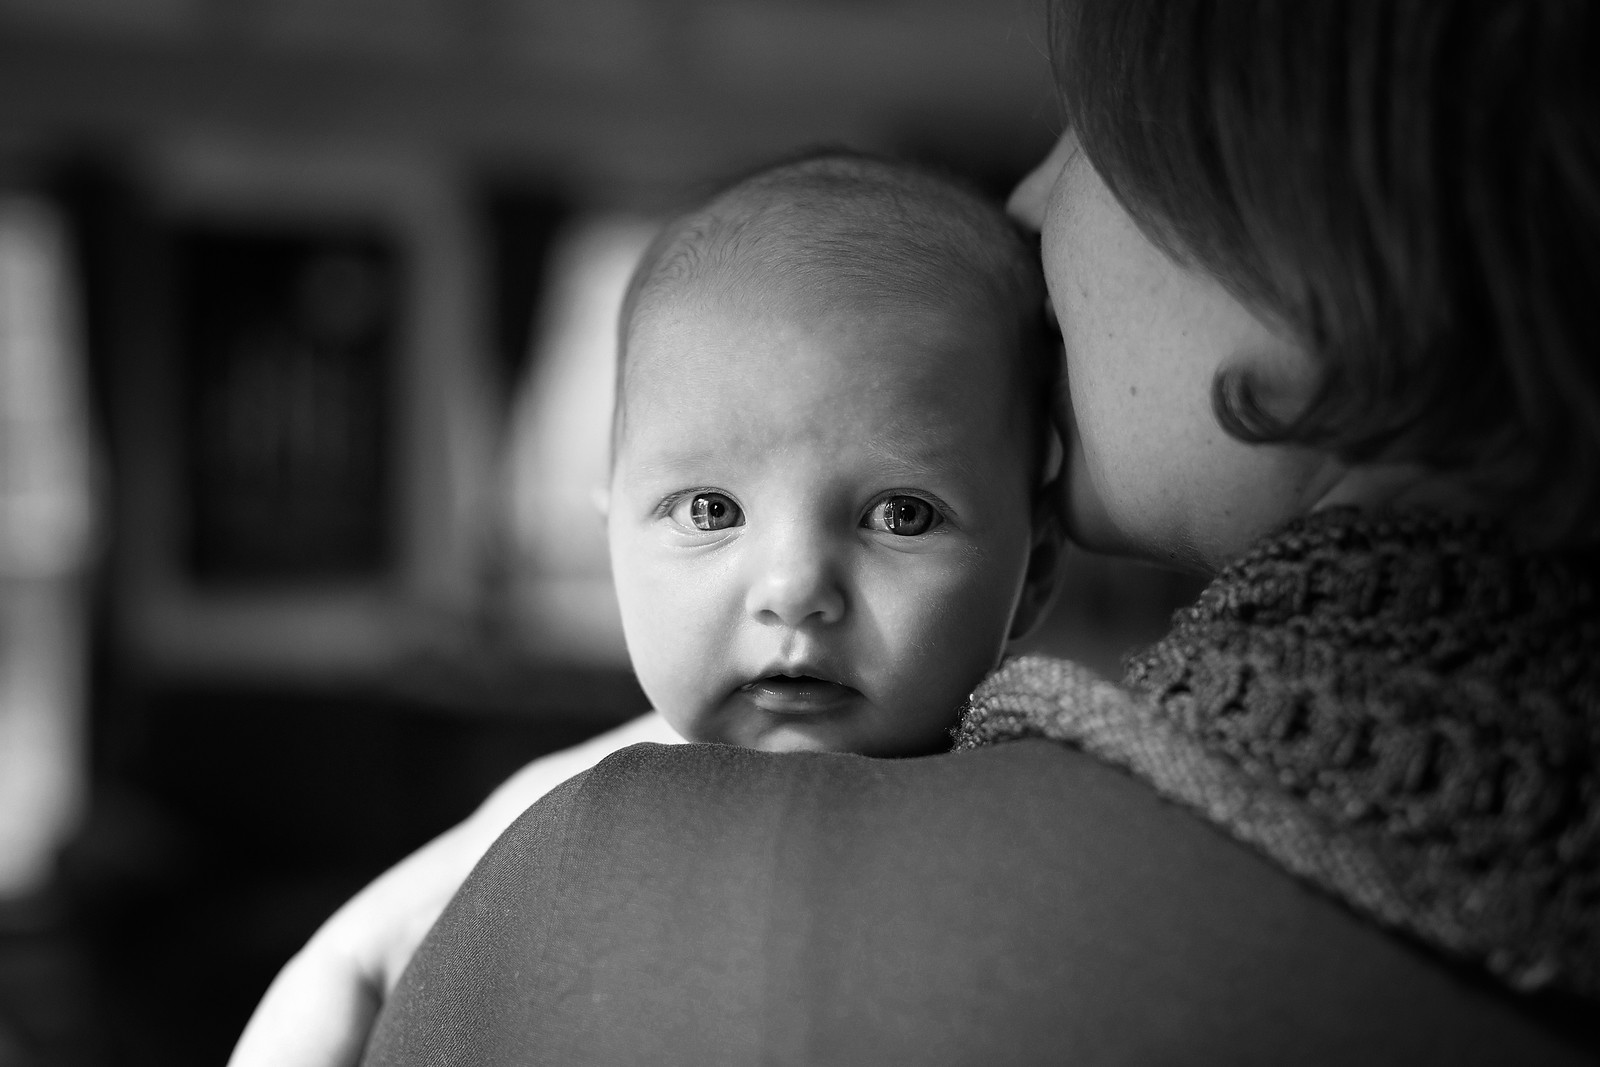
[{"x1": 608, "y1": 289, "x2": 1035, "y2": 755}]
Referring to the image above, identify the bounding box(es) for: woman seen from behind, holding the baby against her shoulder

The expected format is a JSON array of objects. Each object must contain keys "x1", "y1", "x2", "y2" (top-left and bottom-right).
[{"x1": 235, "y1": 0, "x2": 1600, "y2": 1064}]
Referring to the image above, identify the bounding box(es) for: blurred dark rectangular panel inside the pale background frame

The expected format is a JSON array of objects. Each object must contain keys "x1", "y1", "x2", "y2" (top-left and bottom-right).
[{"x1": 173, "y1": 226, "x2": 396, "y2": 587}]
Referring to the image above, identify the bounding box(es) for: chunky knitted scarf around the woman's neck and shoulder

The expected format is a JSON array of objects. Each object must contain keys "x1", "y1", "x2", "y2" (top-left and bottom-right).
[{"x1": 955, "y1": 510, "x2": 1600, "y2": 1000}]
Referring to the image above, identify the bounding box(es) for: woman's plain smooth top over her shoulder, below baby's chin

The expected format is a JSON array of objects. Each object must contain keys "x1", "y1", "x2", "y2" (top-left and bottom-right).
[{"x1": 365, "y1": 741, "x2": 1595, "y2": 1067}]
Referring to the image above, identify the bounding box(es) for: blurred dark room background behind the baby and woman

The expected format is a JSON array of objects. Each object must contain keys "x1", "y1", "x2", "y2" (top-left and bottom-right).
[{"x1": 0, "y1": 0, "x2": 1192, "y2": 1067}]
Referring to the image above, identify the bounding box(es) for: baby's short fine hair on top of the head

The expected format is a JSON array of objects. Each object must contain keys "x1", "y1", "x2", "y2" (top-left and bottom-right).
[{"x1": 613, "y1": 149, "x2": 1059, "y2": 473}]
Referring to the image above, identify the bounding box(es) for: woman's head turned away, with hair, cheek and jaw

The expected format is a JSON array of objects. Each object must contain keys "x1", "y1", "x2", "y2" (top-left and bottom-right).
[{"x1": 1014, "y1": 0, "x2": 1600, "y2": 565}]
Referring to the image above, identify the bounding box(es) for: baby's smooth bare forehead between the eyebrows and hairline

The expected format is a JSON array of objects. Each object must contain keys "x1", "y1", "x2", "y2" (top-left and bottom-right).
[{"x1": 616, "y1": 268, "x2": 1048, "y2": 486}]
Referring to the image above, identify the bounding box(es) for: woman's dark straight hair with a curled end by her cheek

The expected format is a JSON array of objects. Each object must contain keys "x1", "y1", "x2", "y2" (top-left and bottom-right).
[{"x1": 1051, "y1": 0, "x2": 1600, "y2": 542}]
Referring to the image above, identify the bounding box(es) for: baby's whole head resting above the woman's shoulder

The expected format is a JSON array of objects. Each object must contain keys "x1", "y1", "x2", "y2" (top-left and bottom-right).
[{"x1": 606, "y1": 154, "x2": 1059, "y2": 755}]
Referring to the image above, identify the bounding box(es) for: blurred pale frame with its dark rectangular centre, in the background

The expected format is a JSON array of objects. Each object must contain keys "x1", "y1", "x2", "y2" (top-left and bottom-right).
[{"x1": 110, "y1": 138, "x2": 499, "y2": 681}]
